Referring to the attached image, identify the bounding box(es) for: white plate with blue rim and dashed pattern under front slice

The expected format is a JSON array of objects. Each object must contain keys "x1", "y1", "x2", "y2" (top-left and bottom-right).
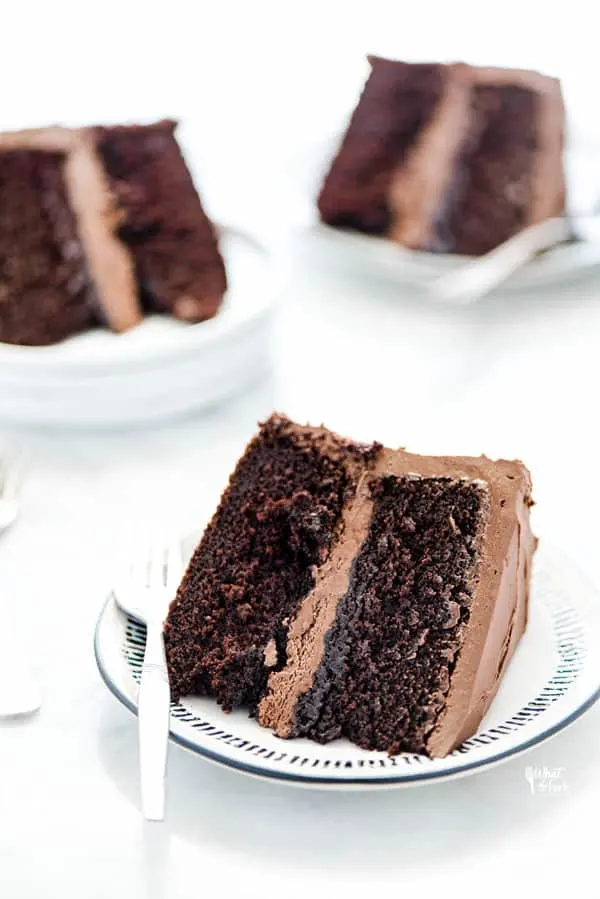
[{"x1": 95, "y1": 540, "x2": 600, "y2": 788}]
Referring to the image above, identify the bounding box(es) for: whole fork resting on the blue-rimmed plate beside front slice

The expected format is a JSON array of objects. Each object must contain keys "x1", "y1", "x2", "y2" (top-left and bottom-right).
[{"x1": 115, "y1": 541, "x2": 183, "y2": 821}]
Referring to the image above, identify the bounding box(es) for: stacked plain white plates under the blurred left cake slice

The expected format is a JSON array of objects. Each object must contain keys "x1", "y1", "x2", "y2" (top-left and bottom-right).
[{"x1": 0, "y1": 227, "x2": 275, "y2": 427}]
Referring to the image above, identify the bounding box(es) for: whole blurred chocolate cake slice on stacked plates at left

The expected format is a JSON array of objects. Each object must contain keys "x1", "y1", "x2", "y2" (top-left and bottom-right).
[{"x1": 0, "y1": 121, "x2": 227, "y2": 345}]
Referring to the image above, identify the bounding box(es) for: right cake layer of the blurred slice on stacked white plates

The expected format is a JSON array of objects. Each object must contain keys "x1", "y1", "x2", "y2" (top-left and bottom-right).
[{"x1": 92, "y1": 121, "x2": 227, "y2": 322}]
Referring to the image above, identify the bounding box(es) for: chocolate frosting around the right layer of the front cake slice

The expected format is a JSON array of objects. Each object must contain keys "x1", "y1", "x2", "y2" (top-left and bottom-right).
[{"x1": 258, "y1": 450, "x2": 536, "y2": 756}]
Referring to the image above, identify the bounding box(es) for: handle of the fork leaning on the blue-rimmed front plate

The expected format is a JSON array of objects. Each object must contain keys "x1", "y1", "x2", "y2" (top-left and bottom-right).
[{"x1": 138, "y1": 621, "x2": 171, "y2": 821}]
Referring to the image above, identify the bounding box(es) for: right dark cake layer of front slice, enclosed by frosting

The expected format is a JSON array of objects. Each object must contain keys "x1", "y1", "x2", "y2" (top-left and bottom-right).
[{"x1": 290, "y1": 476, "x2": 489, "y2": 752}]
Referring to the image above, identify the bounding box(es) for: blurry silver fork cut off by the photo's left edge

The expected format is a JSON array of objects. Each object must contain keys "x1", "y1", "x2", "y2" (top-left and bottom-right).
[{"x1": 0, "y1": 454, "x2": 42, "y2": 717}]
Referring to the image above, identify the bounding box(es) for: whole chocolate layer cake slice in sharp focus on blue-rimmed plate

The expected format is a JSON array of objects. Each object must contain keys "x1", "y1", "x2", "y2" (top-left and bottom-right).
[{"x1": 165, "y1": 416, "x2": 535, "y2": 756}]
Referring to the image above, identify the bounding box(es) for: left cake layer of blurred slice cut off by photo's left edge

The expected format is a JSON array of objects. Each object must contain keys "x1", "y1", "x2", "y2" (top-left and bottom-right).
[{"x1": 0, "y1": 143, "x2": 97, "y2": 346}]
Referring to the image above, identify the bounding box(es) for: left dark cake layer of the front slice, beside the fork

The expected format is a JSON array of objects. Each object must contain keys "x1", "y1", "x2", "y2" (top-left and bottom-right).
[{"x1": 165, "y1": 416, "x2": 377, "y2": 709}]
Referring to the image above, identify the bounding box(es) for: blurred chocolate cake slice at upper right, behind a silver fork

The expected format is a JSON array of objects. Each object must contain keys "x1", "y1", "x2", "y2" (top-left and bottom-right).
[{"x1": 318, "y1": 57, "x2": 565, "y2": 255}]
